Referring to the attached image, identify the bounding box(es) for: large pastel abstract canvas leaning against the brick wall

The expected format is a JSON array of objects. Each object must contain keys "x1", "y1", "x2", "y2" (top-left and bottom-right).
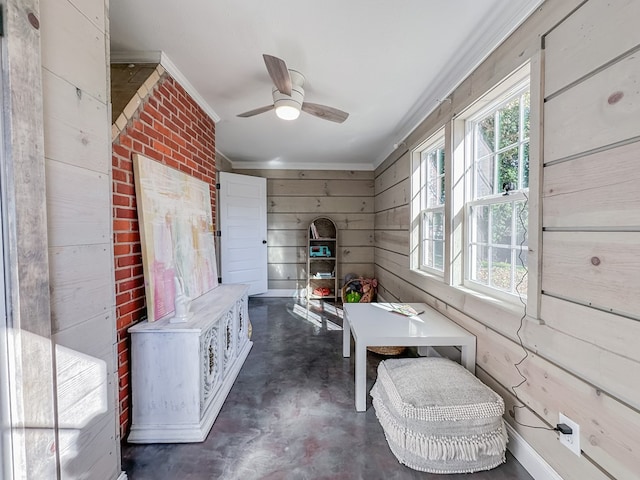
[{"x1": 133, "y1": 155, "x2": 218, "y2": 322}]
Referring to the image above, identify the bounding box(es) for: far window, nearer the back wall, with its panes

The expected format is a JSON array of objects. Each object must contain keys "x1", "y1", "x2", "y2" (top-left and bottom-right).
[{"x1": 412, "y1": 132, "x2": 446, "y2": 275}]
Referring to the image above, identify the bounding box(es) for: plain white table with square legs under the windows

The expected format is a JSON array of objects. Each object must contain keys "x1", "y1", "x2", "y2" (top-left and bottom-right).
[{"x1": 342, "y1": 303, "x2": 476, "y2": 412}]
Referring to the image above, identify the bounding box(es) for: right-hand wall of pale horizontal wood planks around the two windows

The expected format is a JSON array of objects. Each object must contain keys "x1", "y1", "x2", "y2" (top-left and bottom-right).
[{"x1": 375, "y1": 0, "x2": 640, "y2": 480}]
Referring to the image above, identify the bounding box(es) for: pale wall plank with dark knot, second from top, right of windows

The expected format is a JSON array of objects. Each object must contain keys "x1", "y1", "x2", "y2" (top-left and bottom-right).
[{"x1": 544, "y1": 52, "x2": 640, "y2": 164}]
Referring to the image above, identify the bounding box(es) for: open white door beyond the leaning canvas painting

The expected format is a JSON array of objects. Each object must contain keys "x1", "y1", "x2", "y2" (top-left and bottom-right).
[{"x1": 218, "y1": 172, "x2": 267, "y2": 295}]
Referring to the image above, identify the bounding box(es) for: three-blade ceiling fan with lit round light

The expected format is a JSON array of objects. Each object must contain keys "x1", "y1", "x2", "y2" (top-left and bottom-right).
[{"x1": 238, "y1": 54, "x2": 349, "y2": 123}]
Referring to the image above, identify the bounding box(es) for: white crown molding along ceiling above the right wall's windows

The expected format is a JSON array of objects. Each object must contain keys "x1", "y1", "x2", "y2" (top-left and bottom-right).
[{"x1": 374, "y1": 0, "x2": 545, "y2": 168}]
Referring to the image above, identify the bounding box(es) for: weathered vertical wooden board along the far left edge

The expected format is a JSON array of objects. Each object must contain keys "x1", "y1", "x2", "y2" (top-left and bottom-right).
[{"x1": 0, "y1": 0, "x2": 59, "y2": 478}]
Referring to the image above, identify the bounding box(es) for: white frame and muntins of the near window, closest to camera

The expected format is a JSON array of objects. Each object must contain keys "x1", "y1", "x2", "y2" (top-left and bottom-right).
[{"x1": 463, "y1": 80, "x2": 531, "y2": 302}]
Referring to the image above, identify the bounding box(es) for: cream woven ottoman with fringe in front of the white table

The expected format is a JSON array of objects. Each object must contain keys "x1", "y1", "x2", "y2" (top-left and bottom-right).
[{"x1": 371, "y1": 358, "x2": 507, "y2": 473}]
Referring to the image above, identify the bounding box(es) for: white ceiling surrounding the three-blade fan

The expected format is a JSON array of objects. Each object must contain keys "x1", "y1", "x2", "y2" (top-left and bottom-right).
[{"x1": 110, "y1": 0, "x2": 543, "y2": 170}]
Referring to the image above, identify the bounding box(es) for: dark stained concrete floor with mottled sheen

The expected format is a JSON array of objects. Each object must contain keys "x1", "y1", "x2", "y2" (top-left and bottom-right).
[{"x1": 122, "y1": 298, "x2": 532, "y2": 480}]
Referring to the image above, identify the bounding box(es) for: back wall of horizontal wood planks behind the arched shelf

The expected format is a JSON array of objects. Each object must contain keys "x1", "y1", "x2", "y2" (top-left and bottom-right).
[{"x1": 233, "y1": 169, "x2": 374, "y2": 296}]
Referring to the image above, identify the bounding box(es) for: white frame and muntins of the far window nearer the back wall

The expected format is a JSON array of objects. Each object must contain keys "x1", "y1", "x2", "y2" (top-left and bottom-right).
[{"x1": 411, "y1": 128, "x2": 449, "y2": 278}]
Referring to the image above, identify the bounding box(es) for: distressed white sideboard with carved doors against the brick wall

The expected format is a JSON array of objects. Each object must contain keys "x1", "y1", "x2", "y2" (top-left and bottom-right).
[{"x1": 128, "y1": 285, "x2": 252, "y2": 443}]
